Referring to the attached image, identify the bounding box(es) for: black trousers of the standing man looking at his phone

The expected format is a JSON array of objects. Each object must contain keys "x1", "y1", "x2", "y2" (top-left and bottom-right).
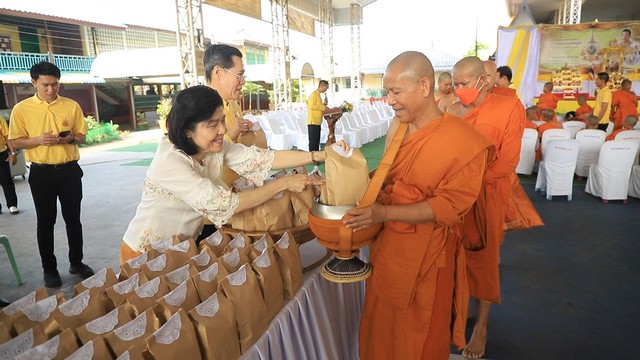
[{"x1": 29, "y1": 161, "x2": 84, "y2": 272}]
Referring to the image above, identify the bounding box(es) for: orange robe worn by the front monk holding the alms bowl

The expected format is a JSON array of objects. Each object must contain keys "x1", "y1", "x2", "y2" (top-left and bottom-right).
[{"x1": 359, "y1": 114, "x2": 493, "y2": 360}]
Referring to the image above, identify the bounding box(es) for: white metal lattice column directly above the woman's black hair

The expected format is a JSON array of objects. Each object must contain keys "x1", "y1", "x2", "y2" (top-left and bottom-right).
[{"x1": 176, "y1": 0, "x2": 204, "y2": 89}]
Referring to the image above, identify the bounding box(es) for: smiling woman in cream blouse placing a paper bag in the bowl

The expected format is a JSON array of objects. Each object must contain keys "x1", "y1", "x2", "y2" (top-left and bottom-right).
[{"x1": 120, "y1": 86, "x2": 348, "y2": 263}]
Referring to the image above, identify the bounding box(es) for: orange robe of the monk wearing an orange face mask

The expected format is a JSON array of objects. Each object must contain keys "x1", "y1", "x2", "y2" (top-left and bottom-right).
[{"x1": 464, "y1": 94, "x2": 525, "y2": 303}]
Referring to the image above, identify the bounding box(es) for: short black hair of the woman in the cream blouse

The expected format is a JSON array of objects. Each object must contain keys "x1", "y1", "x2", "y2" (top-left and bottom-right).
[{"x1": 167, "y1": 85, "x2": 222, "y2": 155}]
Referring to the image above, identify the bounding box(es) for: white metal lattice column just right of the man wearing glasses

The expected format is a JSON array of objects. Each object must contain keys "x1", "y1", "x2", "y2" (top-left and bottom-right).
[{"x1": 271, "y1": 0, "x2": 291, "y2": 109}]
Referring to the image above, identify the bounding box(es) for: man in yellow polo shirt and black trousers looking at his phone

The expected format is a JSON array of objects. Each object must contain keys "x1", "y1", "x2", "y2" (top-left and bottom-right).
[{"x1": 9, "y1": 61, "x2": 93, "y2": 288}]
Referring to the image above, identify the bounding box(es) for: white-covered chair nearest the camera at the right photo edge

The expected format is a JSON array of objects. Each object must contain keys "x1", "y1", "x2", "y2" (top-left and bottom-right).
[{"x1": 585, "y1": 140, "x2": 638, "y2": 203}]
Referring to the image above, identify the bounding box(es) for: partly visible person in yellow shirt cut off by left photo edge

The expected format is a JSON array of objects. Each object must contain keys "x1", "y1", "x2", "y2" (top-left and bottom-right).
[{"x1": 0, "y1": 116, "x2": 20, "y2": 215}]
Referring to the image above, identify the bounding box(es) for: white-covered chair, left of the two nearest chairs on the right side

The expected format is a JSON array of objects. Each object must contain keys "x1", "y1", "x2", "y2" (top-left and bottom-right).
[{"x1": 535, "y1": 139, "x2": 580, "y2": 201}]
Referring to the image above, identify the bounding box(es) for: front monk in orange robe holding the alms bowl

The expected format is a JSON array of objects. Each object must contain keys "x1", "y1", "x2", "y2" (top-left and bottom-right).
[{"x1": 344, "y1": 52, "x2": 493, "y2": 360}]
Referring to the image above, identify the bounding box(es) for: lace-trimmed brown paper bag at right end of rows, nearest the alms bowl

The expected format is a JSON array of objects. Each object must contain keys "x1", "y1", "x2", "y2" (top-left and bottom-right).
[{"x1": 273, "y1": 231, "x2": 302, "y2": 300}]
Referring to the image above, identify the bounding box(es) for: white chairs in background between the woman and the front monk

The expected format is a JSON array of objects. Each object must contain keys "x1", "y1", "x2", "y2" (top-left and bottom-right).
[{"x1": 245, "y1": 101, "x2": 393, "y2": 151}]
